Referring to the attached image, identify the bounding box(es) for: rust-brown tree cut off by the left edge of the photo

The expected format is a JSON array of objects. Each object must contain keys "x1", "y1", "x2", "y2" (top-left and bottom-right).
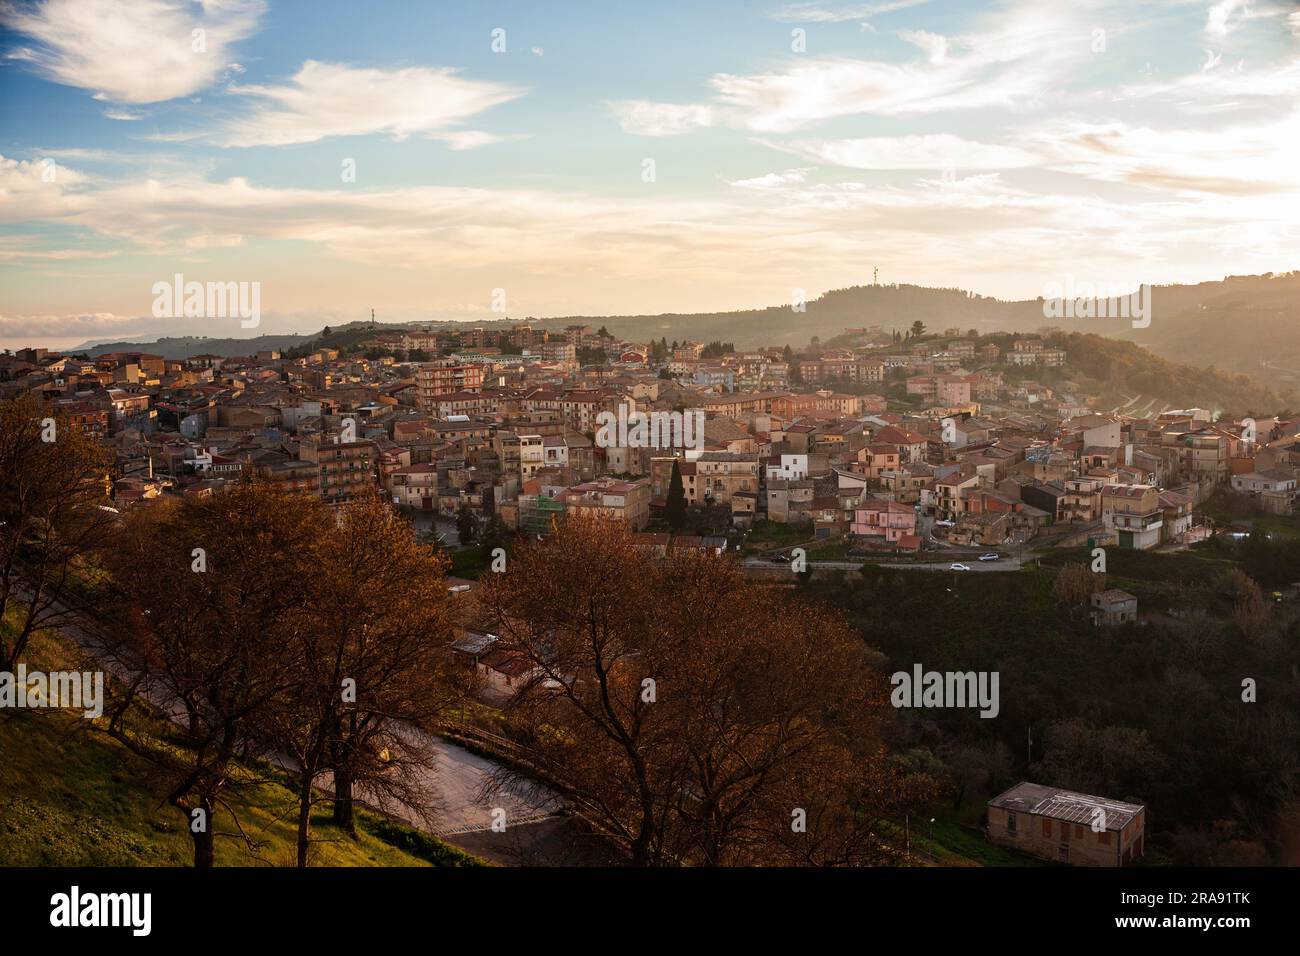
[{"x1": 0, "y1": 395, "x2": 113, "y2": 671}]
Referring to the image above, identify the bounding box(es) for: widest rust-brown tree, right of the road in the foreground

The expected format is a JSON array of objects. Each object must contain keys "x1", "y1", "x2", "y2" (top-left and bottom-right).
[{"x1": 481, "y1": 520, "x2": 928, "y2": 865}]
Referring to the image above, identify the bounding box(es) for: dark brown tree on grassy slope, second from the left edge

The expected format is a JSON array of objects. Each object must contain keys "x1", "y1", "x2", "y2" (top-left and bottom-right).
[{"x1": 108, "y1": 483, "x2": 333, "y2": 868}]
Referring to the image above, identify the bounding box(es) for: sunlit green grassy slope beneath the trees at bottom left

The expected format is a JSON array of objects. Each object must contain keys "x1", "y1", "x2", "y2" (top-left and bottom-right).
[{"x1": 0, "y1": 624, "x2": 478, "y2": 866}]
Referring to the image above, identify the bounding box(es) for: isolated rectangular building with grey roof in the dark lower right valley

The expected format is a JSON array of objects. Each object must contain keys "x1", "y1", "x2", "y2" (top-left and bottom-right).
[{"x1": 985, "y1": 783, "x2": 1147, "y2": 866}]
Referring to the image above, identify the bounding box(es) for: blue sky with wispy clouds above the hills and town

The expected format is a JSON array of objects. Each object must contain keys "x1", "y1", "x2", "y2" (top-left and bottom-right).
[{"x1": 0, "y1": 0, "x2": 1300, "y2": 347}]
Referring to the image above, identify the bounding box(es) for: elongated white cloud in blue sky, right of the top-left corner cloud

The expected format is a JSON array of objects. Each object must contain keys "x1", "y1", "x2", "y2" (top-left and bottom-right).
[{"x1": 218, "y1": 60, "x2": 523, "y2": 148}]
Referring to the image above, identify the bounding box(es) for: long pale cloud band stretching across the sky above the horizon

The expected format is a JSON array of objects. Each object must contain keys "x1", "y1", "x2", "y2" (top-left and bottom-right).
[{"x1": 0, "y1": 143, "x2": 1300, "y2": 303}]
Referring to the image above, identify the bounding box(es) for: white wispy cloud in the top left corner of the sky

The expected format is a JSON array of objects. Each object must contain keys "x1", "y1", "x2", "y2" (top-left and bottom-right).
[{"x1": 0, "y1": 0, "x2": 264, "y2": 103}]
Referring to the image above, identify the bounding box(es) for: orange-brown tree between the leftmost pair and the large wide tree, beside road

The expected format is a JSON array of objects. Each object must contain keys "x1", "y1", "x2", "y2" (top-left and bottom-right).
[{"x1": 277, "y1": 496, "x2": 465, "y2": 866}]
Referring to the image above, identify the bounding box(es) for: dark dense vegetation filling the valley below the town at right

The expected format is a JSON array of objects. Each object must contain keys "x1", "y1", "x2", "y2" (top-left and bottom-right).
[{"x1": 810, "y1": 536, "x2": 1300, "y2": 864}]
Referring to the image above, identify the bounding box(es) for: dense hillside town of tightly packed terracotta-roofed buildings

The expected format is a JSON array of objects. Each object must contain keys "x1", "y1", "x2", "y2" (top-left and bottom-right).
[{"x1": 0, "y1": 324, "x2": 1300, "y2": 557}]
